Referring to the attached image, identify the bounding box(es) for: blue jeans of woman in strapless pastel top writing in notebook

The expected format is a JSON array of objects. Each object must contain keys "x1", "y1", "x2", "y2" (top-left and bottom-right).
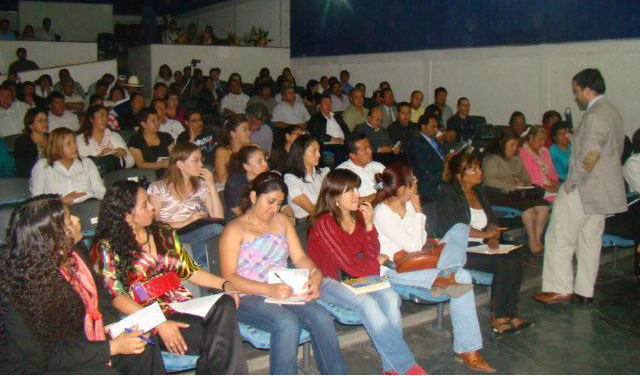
[{"x1": 237, "y1": 295, "x2": 347, "y2": 375}]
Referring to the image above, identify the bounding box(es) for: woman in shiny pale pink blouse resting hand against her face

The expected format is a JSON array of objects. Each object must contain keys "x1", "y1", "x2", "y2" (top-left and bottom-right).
[{"x1": 147, "y1": 142, "x2": 223, "y2": 270}]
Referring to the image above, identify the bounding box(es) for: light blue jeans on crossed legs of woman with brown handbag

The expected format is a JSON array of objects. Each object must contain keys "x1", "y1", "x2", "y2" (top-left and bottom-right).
[{"x1": 383, "y1": 223, "x2": 482, "y2": 354}]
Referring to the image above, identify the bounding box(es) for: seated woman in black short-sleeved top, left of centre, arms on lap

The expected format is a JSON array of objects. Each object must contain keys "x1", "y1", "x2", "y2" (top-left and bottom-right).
[{"x1": 129, "y1": 107, "x2": 175, "y2": 177}]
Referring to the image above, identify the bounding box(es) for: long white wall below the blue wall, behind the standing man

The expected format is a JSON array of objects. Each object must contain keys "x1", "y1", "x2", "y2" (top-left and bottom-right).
[{"x1": 291, "y1": 39, "x2": 640, "y2": 135}]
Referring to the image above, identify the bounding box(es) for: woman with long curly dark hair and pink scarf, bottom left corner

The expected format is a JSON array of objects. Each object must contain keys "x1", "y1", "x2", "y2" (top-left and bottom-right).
[{"x1": 0, "y1": 195, "x2": 165, "y2": 374}]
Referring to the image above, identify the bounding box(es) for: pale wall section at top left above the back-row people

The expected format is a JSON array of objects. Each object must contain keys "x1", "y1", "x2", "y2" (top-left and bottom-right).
[{"x1": 18, "y1": 0, "x2": 113, "y2": 42}]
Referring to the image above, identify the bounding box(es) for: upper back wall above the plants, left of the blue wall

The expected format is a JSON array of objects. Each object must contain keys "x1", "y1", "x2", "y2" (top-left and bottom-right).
[{"x1": 175, "y1": 0, "x2": 290, "y2": 47}]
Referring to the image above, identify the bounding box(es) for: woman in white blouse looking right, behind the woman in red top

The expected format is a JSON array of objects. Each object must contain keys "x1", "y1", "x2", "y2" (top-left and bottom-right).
[{"x1": 284, "y1": 135, "x2": 329, "y2": 219}]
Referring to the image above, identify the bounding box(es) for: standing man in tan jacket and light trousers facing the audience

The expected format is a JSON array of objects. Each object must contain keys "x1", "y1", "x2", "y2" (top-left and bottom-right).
[{"x1": 534, "y1": 68, "x2": 627, "y2": 304}]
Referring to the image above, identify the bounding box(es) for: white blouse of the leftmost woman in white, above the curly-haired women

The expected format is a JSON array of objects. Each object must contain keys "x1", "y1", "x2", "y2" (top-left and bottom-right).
[{"x1": 31, "y1": 157, "x2": 106, "y2": 203}]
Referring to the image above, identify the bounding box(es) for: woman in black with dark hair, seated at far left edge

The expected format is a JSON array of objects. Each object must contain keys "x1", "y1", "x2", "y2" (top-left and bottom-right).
[{"x1": 13, "y1": 107, "x2": 49, "y2": 179}]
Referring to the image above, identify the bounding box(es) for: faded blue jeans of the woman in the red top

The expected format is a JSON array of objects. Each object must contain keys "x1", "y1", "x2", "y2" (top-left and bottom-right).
[{"x1": 320, "y1": 278, "x2": 416, "y2": 375}]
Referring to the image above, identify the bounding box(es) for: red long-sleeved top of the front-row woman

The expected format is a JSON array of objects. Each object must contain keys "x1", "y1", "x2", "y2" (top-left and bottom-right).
[{"x1": 307, "y1": 213, "x2": 380, "y2": 280}]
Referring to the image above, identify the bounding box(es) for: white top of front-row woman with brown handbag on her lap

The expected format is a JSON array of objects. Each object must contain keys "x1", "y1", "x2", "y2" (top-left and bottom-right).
[{"x1": 373, "y1": 201, "x2": 427, "y2": 260}]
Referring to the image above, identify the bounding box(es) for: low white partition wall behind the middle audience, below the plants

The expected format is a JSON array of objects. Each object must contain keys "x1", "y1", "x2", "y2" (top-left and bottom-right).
[{"x1": 128, "y1": 44, "x2": 290, "y2": 95}]
